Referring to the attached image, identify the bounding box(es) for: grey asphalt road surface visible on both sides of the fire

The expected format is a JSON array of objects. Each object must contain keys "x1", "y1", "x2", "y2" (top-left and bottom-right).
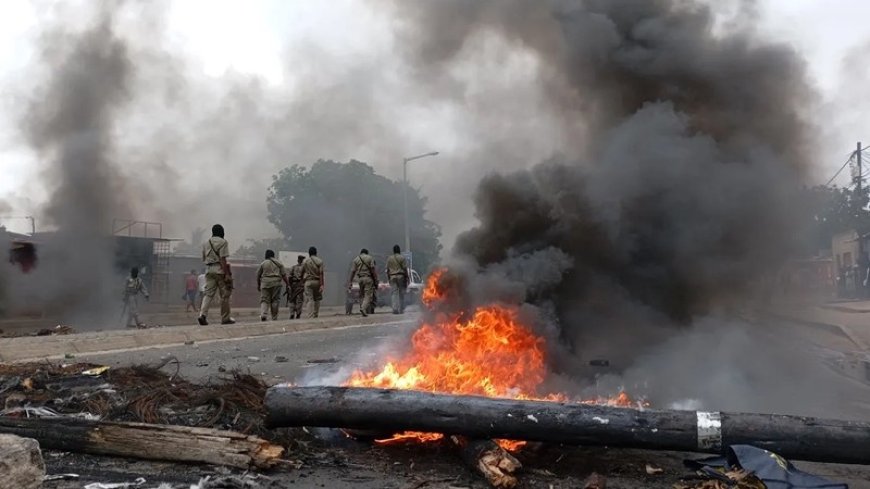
[{"x1": 70, "y1": 314, "x2": 870, "y2": 419}]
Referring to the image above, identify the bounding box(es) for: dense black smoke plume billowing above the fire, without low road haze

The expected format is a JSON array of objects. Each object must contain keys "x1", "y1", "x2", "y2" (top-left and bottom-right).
[{"x1": 399, "y1": 0, "x2": 813, "y2": 348}]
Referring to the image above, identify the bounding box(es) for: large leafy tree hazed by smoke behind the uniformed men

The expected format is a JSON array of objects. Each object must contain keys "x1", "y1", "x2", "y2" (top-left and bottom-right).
[{"x1": 267, "y1": 160, "x2": 441, "y2": 272}]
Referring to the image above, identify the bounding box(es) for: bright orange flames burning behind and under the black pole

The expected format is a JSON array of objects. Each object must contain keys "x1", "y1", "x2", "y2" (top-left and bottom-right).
[{"x1": 346, "y1": 269, "x2": 634, "y2": 450}]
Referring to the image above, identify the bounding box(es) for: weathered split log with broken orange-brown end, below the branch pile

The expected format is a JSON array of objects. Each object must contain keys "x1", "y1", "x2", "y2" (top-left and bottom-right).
[{"x1": 0, "y1": 417, "x2": 284, "y2": 468}]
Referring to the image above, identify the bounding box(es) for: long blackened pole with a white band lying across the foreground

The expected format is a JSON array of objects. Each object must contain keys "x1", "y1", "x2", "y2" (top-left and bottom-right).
[{"x1": 265, "y1": 386, "x2": 870, "y2": 464}]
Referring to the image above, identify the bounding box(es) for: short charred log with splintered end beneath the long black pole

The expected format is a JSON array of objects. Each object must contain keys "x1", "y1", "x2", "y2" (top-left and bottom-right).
[{"x1": 450, "y1": 436, "x2": 523, "y2": 489}]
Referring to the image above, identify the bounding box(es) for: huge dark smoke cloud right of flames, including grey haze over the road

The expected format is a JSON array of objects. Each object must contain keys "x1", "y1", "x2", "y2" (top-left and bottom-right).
[{"x1": 384, "y1": 0, "x2": 864, "y2": 414}]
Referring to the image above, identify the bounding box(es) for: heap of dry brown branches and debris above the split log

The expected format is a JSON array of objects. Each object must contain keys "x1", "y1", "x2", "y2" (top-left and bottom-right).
[{"x1": 0, "y1": 359, "x2": 275, "y2": 438}]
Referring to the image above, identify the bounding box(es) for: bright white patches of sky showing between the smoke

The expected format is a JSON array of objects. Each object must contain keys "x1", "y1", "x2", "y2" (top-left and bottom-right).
[{"x1": 0, "y1": 0, "x2": 870, "y2": 237}]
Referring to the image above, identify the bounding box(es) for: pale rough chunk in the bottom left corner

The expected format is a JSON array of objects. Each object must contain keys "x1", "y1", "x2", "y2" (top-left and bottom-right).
[{"x1": 0, "y1": 435, "x2": 45, "y2": 489}]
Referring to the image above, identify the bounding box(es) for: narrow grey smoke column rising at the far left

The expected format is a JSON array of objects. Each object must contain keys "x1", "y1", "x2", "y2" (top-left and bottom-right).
[{"x1": 15, "y1": 9, "x2": 133, "y2": 321}]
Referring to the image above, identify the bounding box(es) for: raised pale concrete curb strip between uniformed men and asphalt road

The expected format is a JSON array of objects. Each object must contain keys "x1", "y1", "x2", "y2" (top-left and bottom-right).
[{"x1": 0, "y1": 314, "x2": 416, "y2": 363}]
